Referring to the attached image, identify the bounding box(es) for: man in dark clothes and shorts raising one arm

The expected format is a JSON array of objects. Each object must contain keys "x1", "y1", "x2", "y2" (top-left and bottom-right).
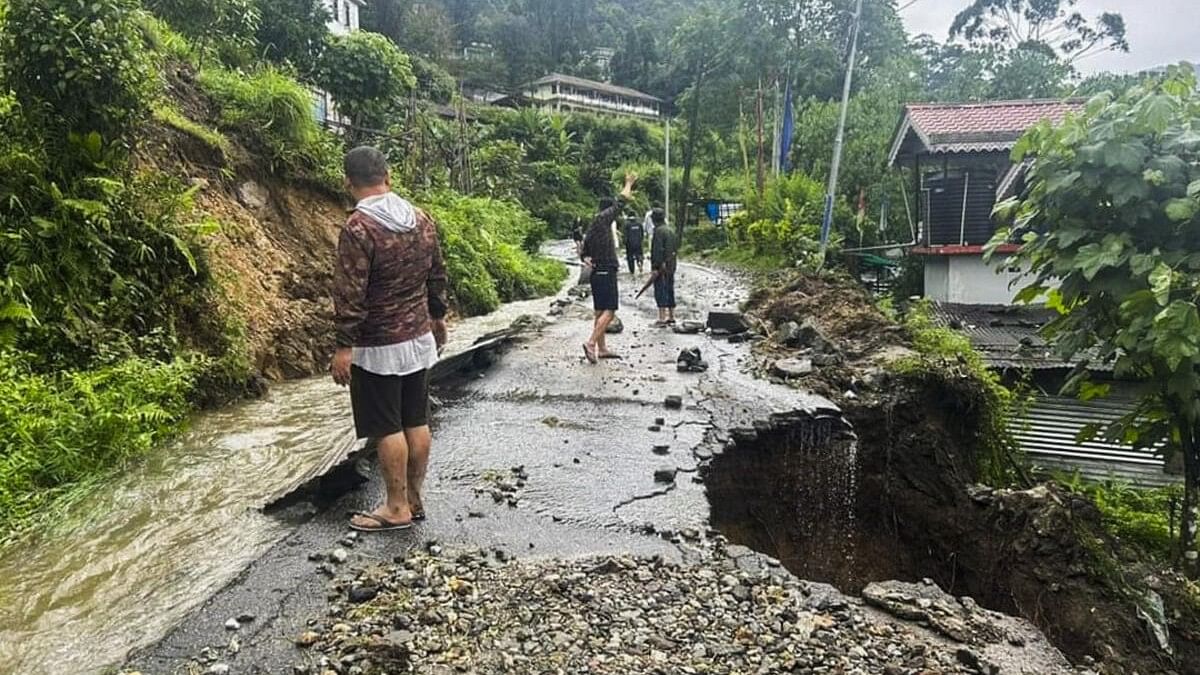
[{"x1": 580, "y1": 173, "x2": 637, "y2": 364}]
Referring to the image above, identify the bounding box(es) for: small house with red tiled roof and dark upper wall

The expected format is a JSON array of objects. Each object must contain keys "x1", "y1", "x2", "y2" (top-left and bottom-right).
[{"x1": 888, "y1": 100, "x2": 1084, "y2": 304}]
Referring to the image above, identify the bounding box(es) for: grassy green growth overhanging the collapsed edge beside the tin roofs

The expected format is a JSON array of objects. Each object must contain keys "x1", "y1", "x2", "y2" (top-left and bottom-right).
[{"x1": 892, "y1": 301, "x2": 1028, "y2": 486}]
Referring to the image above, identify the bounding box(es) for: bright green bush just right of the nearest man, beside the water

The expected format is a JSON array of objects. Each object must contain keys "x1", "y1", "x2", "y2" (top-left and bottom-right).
[{"x1": 427, "y1": 192, "x2": 566, "y2": 316}]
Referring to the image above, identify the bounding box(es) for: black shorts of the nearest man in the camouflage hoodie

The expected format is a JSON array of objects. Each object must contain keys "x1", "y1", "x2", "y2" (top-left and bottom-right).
[{"x1": 350, "y1": 365, "x2": 430, "y2": 438}]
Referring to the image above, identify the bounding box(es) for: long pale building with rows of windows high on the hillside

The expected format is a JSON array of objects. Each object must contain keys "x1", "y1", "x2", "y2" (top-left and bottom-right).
[{"x1": 499, "y1": 73, "x2": 664, "y2": 119}]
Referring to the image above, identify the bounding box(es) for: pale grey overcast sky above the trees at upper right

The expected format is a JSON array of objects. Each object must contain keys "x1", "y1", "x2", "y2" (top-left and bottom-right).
[{"x1": 899, "y1": 0, "x2": 1200, "y2": 73}]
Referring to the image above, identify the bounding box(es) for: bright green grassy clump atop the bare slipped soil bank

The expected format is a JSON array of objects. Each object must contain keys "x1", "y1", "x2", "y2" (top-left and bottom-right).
[{"x1": 199, "y1": 67, "x2": 342, "y2": 183}]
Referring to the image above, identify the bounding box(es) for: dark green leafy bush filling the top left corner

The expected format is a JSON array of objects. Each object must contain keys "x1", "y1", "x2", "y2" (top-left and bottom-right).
[{"x1": 0, "y1": 0, "x2": 154, "y2": 149}]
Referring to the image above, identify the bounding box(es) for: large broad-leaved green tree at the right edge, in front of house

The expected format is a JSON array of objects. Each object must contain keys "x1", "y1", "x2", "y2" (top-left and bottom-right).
[{"x1": 994, "y1": 65, "x2": 1200, "y2": 573}]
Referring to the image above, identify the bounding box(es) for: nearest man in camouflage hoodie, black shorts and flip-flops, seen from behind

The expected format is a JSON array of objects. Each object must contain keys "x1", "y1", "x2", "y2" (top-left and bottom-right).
[{"x1": 330, "y1": 147, "x2": 448, "y2": 532}]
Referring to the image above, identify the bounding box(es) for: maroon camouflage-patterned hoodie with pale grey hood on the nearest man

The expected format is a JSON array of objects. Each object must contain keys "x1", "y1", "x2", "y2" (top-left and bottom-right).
[{"x1": 334, "y1": 192, "x2": 448, "y2": 347}]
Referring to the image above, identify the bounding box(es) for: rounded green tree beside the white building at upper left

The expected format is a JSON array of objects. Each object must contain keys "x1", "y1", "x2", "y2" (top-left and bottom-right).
[{"x1": 316, "y1": 31, "x2": 416, "y2": 129}]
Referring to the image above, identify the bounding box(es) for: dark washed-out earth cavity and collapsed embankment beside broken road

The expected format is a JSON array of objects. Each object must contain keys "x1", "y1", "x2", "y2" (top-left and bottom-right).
[{"x1": 704, "y1": 271, "x2": 1200, "y2": 673}]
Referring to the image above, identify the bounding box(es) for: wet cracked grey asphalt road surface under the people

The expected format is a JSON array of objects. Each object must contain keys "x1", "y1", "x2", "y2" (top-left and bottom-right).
[{"x1": 126, "y1": 254, "x2": 834, "y2": 674}]
